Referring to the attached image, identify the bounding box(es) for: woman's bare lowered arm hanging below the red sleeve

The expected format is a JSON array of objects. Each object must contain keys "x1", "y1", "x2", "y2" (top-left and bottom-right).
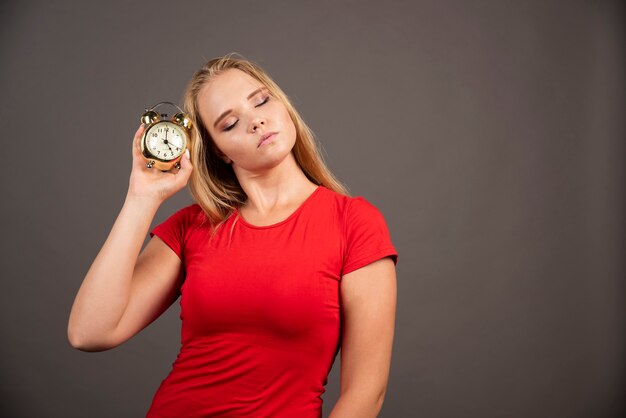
[{"x1": 329, "y1": 257, "x2": 397, "y2": 418}]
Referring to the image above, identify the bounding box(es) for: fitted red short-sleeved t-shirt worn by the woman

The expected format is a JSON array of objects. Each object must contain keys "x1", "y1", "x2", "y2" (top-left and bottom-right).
[{"x1": 147, "y1": 186, "x2": 397, "y2": 418}]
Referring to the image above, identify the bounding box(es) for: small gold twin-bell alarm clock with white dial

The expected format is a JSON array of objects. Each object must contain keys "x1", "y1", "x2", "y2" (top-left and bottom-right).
[{"x1": 141, "y1": 102, "x2": 191, "y2": 171}]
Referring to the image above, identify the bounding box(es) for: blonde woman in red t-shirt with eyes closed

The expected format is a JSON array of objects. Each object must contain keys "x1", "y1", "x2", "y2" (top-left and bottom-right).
[{"x1": 68, "y1": 56, "x2": 397, "y2": 418}]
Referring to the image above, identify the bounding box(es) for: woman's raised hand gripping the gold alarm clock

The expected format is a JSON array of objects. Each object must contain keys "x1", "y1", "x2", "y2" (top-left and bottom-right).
[{"x1": 128, "y1": 125, "x2": 193, "y2": 204}]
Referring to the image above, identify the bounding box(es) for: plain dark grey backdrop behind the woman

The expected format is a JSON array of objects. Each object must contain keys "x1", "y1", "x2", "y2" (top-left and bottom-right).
[{"x1": 0, "y1": 0, "x2": 626, "y2": 418}]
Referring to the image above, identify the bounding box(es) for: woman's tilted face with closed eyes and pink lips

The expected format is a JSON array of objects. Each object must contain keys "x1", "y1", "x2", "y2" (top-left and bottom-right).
[{"x1": 198, "y1": 69, "x2": 296, "y2": 174}]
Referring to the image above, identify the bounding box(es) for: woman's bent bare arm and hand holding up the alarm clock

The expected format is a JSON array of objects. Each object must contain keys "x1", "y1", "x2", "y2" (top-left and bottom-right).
[{"x1": 67, "y1": 127, "x2": 192, "y2": 351}]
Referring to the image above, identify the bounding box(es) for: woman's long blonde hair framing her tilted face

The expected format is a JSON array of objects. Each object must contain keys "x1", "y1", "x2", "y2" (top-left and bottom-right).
[{"x1": 184, "y1": 54, "x2": 349, "y2": 229}]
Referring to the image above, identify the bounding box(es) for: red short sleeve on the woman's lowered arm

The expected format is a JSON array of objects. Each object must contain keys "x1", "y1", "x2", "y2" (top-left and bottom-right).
[{"x1": 342, "y1": 197, "x2": 398, "y2": 275}]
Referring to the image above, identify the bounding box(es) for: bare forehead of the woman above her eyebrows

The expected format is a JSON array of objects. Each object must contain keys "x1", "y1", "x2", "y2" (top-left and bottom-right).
[{"x1": 198, "y1": 69, "x2": 263, "y2": 122}]
